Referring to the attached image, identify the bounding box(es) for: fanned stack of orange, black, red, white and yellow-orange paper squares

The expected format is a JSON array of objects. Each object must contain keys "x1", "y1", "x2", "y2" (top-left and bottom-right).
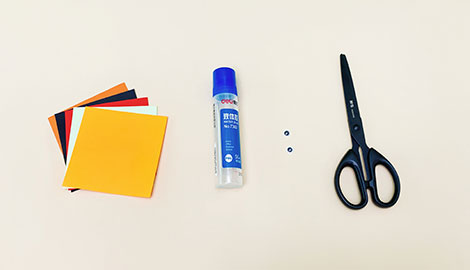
[{"x1": 49, "y1": 83, "x2": 167, "y2": 197}]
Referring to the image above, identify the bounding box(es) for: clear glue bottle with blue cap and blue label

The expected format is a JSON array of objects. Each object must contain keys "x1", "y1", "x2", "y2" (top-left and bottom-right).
[{"x1": 212, "y1": 67, "x2": 243, "y2": 188}]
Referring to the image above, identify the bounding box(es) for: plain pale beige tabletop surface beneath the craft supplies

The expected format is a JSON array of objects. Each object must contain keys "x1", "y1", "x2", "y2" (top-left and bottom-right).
[{"x1": 0, "y1": 1, "x2": 470, "y2": 270}]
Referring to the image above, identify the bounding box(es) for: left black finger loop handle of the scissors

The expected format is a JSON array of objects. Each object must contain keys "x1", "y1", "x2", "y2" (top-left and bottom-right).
[{"x1": 335, "y1": 150, "x2": 367, "y2": 210}]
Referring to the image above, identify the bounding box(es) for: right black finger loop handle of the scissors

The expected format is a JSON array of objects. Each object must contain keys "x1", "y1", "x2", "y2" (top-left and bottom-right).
[{"x1": 367, "y1": 148, "x2": 400, "y2": 208}]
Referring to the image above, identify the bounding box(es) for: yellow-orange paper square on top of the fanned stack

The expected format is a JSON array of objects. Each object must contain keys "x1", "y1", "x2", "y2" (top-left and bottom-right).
[{"x1": 62, "y1": 107, "x2": 168, "y2": 197}]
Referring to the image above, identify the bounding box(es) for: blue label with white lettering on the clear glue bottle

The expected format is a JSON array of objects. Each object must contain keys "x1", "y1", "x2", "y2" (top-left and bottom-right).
[{"x1": 220, "y1": 109, "x2": 242, "y2": 169}]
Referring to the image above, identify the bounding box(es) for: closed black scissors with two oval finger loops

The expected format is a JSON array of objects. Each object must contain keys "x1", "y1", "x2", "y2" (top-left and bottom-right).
[{"x1": 335, "y1": 54, "x2": 400, "y2": 209}]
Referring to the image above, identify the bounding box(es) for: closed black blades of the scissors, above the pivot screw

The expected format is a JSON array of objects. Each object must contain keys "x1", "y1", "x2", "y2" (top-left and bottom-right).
[{"x1": 340, "y1": 54, "x2": 360, "y2": 122}]
